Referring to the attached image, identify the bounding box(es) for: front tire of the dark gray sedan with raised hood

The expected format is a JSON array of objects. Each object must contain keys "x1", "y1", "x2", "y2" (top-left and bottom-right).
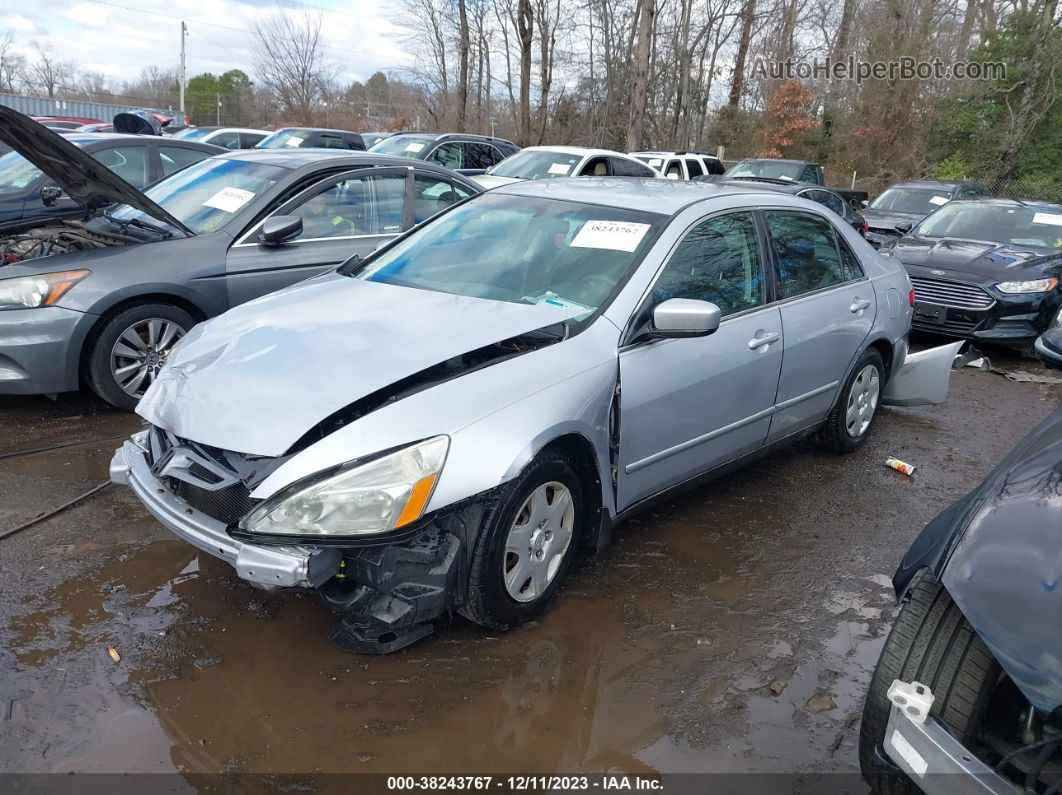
[{"x1": 85, "y1": 303, "x2": 195, "y2": 411}]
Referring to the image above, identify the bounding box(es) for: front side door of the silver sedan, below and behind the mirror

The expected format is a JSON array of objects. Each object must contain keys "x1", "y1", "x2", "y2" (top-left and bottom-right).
[{"x1": 618, "y1": 210, "x2": 783, "y2": 509}]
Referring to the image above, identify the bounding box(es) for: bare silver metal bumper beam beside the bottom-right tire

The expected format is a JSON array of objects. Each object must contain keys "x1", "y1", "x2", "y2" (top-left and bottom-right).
[{"x1": 885, "y1": 679, "x2": 1020, "y2": 795}]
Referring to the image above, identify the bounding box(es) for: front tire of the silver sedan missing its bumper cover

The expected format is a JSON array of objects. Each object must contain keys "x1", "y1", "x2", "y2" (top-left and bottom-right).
[{"x1": 459, "y1": 451, "x2": 585, "y2": 630}]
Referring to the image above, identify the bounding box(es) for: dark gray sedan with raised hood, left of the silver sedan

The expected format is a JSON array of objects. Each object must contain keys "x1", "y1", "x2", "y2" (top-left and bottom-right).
[{"x1": 0, "y1": 107, "x2": 481, "y2": 409}]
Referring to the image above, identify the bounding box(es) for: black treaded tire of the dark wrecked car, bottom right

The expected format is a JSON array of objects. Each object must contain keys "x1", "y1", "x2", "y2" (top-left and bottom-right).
[{"x1": 859, "y1": 574, "x2": 1000, "y2": 795}]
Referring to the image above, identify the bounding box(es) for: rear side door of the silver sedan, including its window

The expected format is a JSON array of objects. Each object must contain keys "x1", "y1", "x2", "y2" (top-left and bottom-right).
[{"x1": 764, "y1": 210, "x2": 877, "y2": 442}]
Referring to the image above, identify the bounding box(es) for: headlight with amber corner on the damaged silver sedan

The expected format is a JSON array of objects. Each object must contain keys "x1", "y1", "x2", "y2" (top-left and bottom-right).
[{"x1": 240, "y1": 436, "x2": 450, "y2": 537}]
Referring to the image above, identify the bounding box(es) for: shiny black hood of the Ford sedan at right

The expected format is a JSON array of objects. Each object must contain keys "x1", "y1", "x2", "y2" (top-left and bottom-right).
[{"x1": 892, "y1": 236, "x2": 1062, "y2": 281}]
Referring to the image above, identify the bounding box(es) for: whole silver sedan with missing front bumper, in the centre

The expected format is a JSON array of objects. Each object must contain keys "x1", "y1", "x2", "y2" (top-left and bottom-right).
[{"x1": 112, "y1": 177, "x2": 953, "y2": 653}]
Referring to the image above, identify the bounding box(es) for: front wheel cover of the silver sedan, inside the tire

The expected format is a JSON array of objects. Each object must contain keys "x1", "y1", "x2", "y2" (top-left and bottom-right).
[{"x1": 502, "y1": 481, "x2": 576, "y2": 602}]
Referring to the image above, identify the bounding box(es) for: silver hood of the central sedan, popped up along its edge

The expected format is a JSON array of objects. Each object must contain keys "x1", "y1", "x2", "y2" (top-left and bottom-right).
[{"x1": 137, "y1": 275, "x2": 583, "y2": 456}]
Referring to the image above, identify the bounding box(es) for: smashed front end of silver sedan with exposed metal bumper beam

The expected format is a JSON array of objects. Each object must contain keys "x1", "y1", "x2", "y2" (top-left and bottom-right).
[{"x1": 110, "y1": 427, "x2": 489, "y2": 654}]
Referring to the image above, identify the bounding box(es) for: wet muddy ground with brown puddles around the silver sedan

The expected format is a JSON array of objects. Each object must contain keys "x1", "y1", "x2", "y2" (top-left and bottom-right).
[{"x1": 0, "y1": 337, "x2": 1062, "y2": 789}]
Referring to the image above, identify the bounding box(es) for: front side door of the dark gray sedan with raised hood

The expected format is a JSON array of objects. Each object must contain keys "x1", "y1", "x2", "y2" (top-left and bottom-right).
[{"x1": 225, "y1": 167, "x2": 418, "y2": 306}]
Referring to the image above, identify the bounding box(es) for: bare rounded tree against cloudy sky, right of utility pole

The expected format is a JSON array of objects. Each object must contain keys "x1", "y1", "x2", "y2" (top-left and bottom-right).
[{"x1": 254, "y1": 11, "x2": 336, "y2": 124}]
